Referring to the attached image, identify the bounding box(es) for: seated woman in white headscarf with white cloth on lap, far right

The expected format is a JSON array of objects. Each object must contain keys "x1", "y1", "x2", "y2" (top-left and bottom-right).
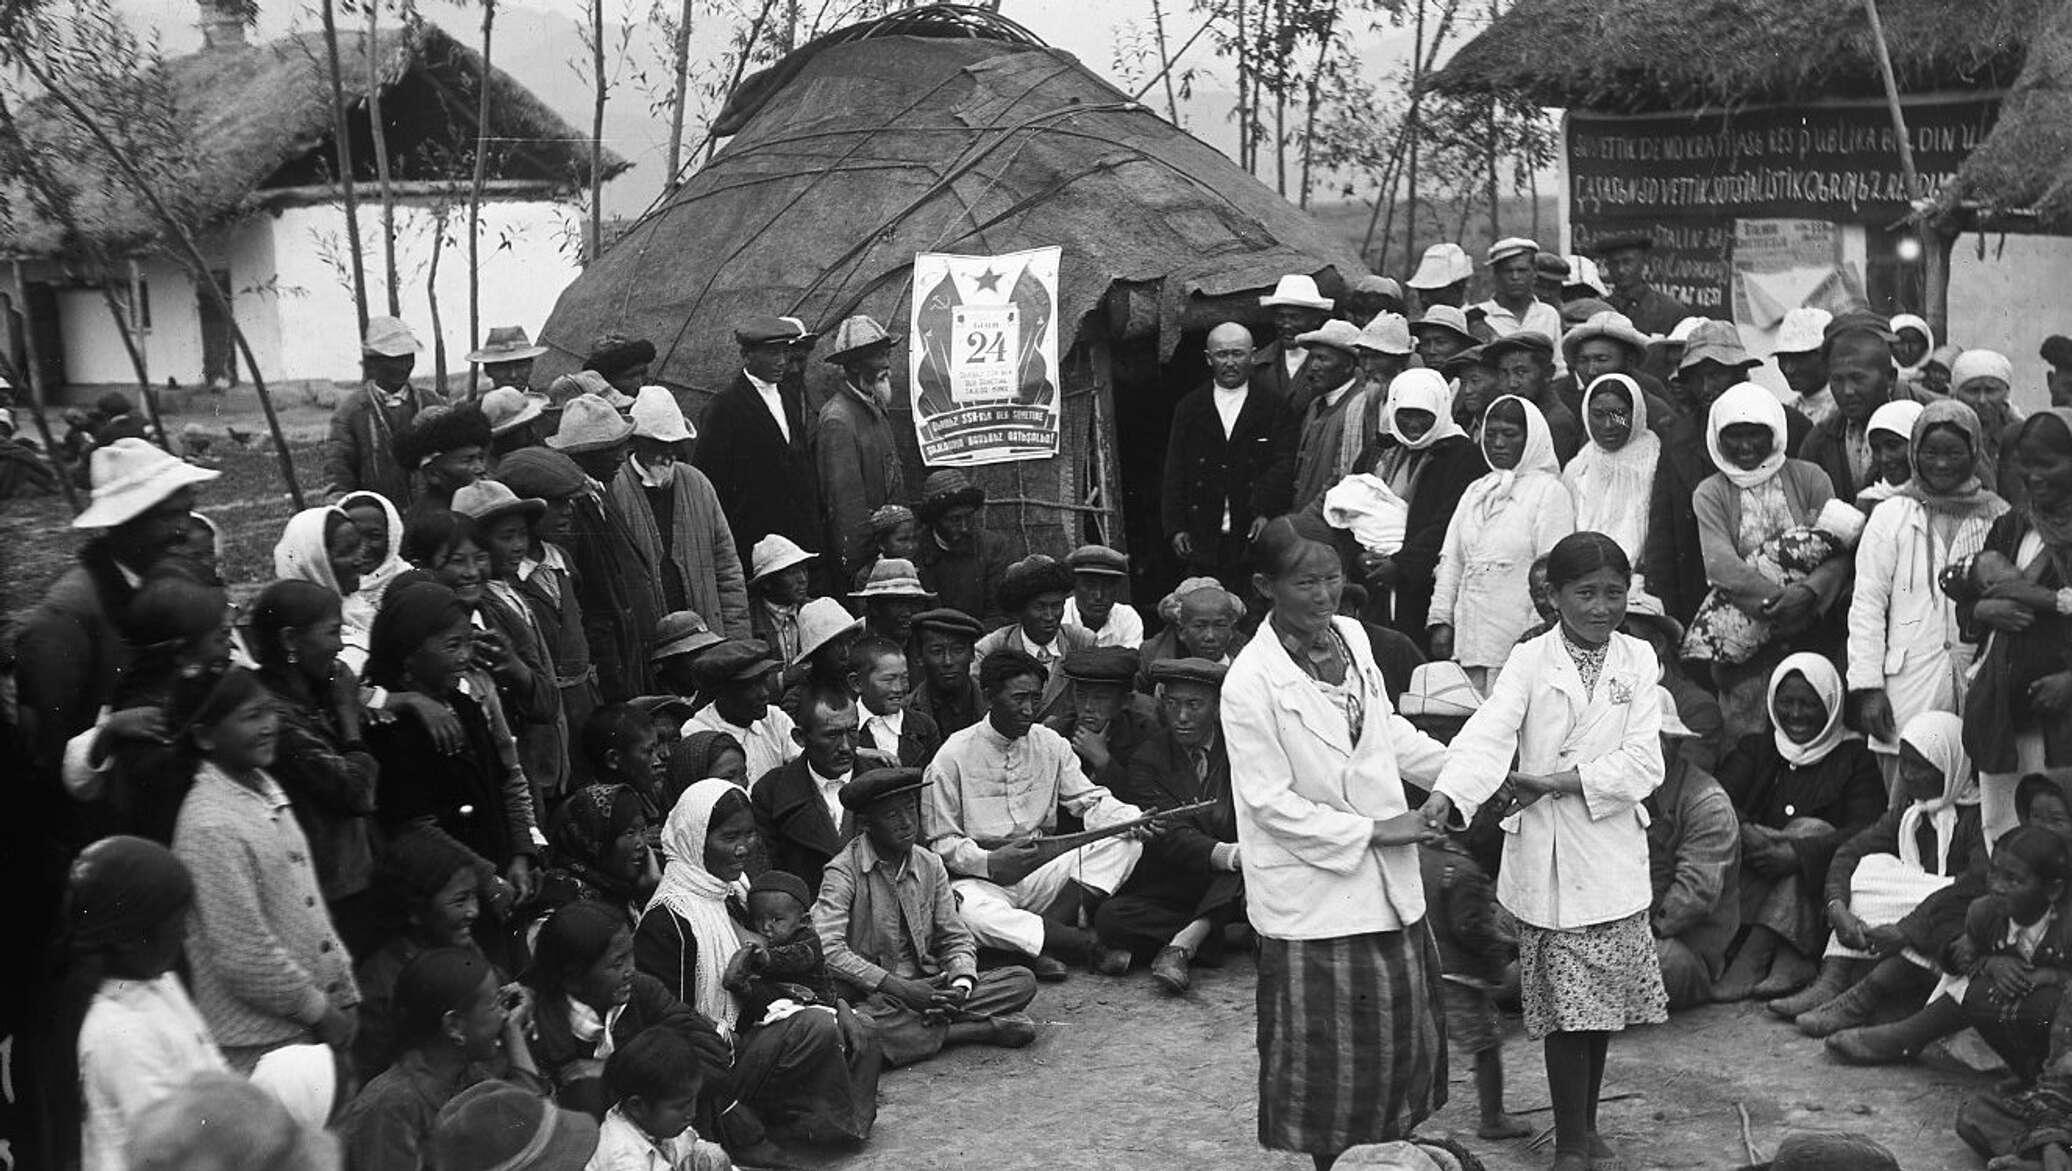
[{"x1": 1796, "y1": 711, "x2": 1985, "y2": 1036}]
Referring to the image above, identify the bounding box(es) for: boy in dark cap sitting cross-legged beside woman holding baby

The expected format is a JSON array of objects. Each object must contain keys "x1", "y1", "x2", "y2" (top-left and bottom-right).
[{"x1": 812, "y1": 769, "x2": 1036, "y2": 1065}]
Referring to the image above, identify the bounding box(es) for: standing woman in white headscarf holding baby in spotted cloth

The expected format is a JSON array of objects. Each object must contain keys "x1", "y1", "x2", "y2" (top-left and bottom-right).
[{"x1": 1691, "y1": 381, "x2": 1848, "y2": 736}]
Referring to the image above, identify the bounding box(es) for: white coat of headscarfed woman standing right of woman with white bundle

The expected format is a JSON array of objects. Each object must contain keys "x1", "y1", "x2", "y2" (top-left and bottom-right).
[{"x1": 1426, "y1": 473, "x2": 1575, "y2": 667}]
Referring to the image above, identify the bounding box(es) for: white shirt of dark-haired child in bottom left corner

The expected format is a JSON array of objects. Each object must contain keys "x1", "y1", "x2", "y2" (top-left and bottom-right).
[{"x1": 79, "y1": 972, "x2": 228, "y2": 1171}]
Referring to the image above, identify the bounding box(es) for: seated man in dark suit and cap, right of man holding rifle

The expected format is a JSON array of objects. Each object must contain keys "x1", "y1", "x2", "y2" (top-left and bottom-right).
[{"x1": 1094, "y1": 659, "x2": 1245, "y2": 993}]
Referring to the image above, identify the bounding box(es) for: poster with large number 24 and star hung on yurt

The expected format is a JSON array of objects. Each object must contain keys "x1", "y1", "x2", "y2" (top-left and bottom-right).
[{"x1": 908, "y1": 249, "x2": 1061, "y2": 468}]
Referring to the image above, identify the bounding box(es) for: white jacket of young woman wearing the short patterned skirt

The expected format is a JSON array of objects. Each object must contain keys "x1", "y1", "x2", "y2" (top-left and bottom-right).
[{"x1": 1442, "y1": 630, "x2": 1662, "y2": 931}]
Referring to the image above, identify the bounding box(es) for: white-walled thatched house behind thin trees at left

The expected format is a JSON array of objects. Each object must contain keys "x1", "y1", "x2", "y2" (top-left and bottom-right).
[{"x1": 0, "y1": 6, "x2": 628, "y2": 400}]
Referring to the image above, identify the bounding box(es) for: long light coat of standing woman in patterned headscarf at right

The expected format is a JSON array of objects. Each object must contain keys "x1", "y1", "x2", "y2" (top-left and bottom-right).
[{"x1": 1848, "y1": 495, "x2": 1993, "y2": 752}]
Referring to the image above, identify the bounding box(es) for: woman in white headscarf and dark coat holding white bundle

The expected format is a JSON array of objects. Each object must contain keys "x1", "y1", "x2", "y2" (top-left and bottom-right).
[{"x1": 1353, "y1": 369, "x2": 1490, "y2": 649}]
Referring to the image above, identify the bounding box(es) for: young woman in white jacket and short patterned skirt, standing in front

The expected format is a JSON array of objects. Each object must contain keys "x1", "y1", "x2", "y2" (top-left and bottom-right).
[{"x1": 1421, "y1": 533, "x2": 1668, "y2": 1171}]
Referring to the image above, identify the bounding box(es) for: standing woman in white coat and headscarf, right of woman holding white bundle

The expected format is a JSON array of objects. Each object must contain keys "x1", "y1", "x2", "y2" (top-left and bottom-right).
[{"x1": 1428, "y1": 394, "x2": 1575, "y2": 694}]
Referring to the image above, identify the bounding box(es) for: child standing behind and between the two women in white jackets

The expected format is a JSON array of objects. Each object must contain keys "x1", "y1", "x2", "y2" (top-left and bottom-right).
[{"x1": 1417, "y1": 833, "x2": 1533, "y2": 1138}]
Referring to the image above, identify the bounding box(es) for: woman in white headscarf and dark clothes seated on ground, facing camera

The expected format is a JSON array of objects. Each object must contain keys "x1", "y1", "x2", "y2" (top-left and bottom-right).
[{"x1": 1711, "y1": 653, "x2": 1886, "y2": 998}]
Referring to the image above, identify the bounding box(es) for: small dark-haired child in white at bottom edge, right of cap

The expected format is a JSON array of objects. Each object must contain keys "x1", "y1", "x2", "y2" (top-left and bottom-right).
[{"x1": 584, "y1": 1028, "x2": 733, "y2": 1171}]
